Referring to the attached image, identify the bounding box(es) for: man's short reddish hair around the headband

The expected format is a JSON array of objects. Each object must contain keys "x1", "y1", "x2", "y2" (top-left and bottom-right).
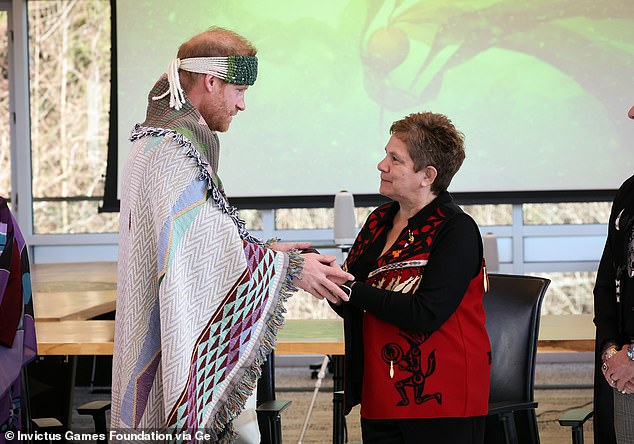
[{"x1": 177, "y1": 26, "x2": 257, "y2": 91}]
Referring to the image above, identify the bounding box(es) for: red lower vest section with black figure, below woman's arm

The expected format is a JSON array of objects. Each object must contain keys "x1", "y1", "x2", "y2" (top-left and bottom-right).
[{"x1": 361, "y1": 272, "x2": 490, "y2": 419}]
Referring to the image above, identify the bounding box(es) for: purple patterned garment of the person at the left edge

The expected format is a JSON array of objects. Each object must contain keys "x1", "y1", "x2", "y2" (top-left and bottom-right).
[{"x1": 0, "y1": 197, "x2": 37, "y2": 444}]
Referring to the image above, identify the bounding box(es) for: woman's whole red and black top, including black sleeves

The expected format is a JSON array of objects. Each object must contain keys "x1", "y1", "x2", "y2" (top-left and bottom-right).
[{"x1": 334, "y1": 192, "x2": 490, "y2": 419}]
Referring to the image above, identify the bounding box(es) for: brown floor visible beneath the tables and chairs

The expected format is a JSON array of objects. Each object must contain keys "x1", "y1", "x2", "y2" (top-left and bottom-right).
[{"x1": 73, "y1": 358, "x2": 593, "y2": 444}]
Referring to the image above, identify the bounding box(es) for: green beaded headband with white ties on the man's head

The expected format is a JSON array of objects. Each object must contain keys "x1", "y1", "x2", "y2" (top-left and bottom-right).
[{"x1": 152, "y1": 56, "x2": 258, "y2": 109}]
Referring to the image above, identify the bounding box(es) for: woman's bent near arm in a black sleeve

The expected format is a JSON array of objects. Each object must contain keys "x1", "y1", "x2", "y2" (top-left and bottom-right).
[{"x1": 349, "y1": 214, "x2": 482, "y2": 332}]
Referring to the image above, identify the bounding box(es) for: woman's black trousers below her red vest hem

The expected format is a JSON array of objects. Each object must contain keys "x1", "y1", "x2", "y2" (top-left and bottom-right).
[{"x1": 361, "y1": 416, "x2": 486, "y2": 444}]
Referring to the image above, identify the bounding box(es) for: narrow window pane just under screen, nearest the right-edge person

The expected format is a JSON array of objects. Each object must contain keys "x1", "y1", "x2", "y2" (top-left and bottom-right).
[{"x1": 523, "y1": 202, "x2": 612, "y2": 225}]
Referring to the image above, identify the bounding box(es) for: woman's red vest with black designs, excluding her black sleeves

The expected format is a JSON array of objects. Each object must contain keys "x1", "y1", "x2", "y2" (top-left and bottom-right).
[{"x1": 348, "y1": 206, "x2": 491, "y2": 419}]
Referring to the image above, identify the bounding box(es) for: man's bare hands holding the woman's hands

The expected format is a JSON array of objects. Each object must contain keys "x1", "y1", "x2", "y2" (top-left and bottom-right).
[{"x1": 270, "y1": 242, "x2": 354, "y2": 305}]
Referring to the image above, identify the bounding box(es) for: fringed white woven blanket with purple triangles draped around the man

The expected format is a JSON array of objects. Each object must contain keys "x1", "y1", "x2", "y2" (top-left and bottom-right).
[{"x1": 111, "y1": 78, "x2": 302, "y2": 442}]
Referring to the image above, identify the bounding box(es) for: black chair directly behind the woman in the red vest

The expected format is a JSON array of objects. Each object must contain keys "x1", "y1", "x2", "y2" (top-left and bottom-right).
[{"x1": 484, "y1": 274, "x2": 550, "y2": 444}]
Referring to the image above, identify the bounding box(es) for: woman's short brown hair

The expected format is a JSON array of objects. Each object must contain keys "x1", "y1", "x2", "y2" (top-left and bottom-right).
[{"x1": 390, "y1": 112, "x2": 465, "y2": 195}]
